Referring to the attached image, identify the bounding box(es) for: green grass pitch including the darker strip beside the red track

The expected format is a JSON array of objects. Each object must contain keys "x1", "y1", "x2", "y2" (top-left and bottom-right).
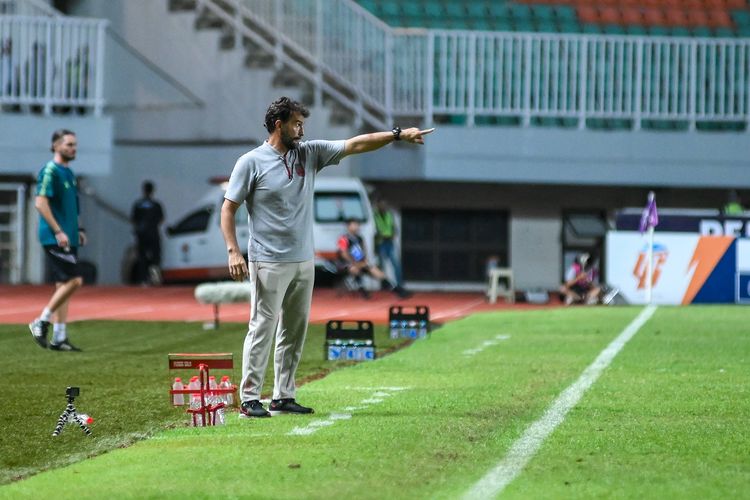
[{"x1": 0, "y1": 306, "x2": 750, "y2": 498}]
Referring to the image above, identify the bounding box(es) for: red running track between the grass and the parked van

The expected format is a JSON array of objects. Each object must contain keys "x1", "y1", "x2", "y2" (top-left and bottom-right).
[{"x1": 0, "y1": 285, "x2": 558, "y2": 324}]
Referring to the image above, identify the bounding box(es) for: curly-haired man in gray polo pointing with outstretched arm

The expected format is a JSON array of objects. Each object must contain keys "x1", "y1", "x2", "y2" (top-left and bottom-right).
[{"x1": 221, "y1": 97, "x2": 433, "y2": 417}]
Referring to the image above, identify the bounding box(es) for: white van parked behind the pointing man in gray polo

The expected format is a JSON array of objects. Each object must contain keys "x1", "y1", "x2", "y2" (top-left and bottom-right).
[{"x1": 162, "y1": 177, "x2": 375, "y2": 282}]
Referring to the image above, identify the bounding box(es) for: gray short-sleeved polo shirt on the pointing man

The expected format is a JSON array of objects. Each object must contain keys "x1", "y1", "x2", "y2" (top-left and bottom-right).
[{"x1": 224, "y1": 141, "x2": 346, "y2": 262}]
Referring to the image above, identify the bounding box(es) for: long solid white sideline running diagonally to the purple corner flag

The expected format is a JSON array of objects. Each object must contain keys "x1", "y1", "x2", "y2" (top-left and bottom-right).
[{"x1": 464, "y1": 305, "x2": 656, "y2": 500}]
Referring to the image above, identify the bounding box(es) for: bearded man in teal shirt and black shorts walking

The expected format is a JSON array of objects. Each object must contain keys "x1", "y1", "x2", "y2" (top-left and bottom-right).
[{"x1": 29, "y1": 129, "x2": 86, "y2": 351}]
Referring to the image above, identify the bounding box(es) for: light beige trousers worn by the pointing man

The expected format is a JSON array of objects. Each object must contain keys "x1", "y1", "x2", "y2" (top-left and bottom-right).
[{"x1": 240, "y1": 260, "x2": 315, "y2": 401}]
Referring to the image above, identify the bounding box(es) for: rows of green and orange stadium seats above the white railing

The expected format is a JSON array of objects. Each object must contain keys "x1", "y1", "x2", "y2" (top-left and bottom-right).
[{"x1": 359, "y1": 0, "x2": 750, "y2": 37}]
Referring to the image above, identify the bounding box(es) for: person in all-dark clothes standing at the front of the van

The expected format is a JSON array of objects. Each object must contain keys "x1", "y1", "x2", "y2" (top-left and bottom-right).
[{"x1": 130, "y1": 181, "x2": 164, "y2": 284}]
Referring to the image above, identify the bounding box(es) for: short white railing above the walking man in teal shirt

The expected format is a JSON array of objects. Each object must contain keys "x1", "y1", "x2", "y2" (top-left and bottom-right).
[{"x1": 0, "y1": 13, "x2": 107, "y2": 116}]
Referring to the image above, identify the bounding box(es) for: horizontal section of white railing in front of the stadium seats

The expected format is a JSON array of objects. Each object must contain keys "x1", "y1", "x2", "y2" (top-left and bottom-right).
[{"x1": 406, "y1": 31, "x2": 750, "y2": 129}]
